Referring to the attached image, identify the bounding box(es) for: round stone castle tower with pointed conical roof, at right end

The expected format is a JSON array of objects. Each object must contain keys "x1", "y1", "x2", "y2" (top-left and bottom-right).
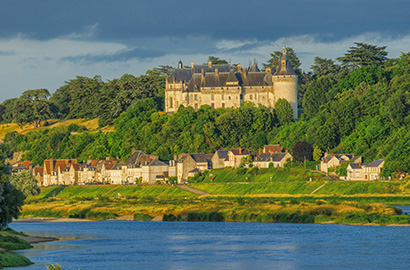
[{"x1": 272, "y1": 44, "x2": 298, "y2": 120}]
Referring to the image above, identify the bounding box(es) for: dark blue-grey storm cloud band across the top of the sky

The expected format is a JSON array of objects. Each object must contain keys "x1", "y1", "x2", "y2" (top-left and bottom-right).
[{"x1": 0, "y1": 0, "x2": 410, "y2": 41}]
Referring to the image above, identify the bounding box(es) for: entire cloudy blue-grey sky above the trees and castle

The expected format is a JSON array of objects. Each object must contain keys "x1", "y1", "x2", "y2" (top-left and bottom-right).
[{"x1": 0, "y1": 0, "x2": 410, "y2": 102}]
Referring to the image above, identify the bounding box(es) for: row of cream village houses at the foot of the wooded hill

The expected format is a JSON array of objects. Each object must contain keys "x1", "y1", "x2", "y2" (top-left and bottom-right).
[{"x1": 11, "y1": 144, "x2": 384, "y2": 186}]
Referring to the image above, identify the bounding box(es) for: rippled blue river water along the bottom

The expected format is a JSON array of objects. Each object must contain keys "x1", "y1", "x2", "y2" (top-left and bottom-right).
[{"x1": 5, "y1": 221, "x2": 410, "y2": 270}]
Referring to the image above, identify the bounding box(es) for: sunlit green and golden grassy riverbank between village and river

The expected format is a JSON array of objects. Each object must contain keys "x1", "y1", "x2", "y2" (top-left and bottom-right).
[{"x1": 17, "y1": 177, "x2": 410, "y2": 225}]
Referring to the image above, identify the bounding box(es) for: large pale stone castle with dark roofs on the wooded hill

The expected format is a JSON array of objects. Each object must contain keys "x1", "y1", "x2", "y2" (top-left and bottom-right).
[{"x1": 165, "y1": 45, "x2": 298, "y2": 119}]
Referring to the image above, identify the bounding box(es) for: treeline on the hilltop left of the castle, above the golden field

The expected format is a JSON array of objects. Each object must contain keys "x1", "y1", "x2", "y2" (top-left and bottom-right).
[{"x1": 0, "y1": 66, "x2": 170, "y2": 127}]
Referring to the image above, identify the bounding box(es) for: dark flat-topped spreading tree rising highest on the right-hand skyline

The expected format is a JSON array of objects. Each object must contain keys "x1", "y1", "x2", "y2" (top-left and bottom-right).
[{"x1": 336, "y1": 42, "x2": 387, "y2": 71}]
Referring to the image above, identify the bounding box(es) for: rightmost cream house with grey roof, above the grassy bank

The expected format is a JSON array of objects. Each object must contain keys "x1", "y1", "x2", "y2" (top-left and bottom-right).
[{"x1": 346, "y1": 159, "x2": 384, "y2": 181}]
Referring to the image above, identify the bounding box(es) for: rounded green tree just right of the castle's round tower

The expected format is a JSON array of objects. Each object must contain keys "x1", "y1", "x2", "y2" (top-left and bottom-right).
[{"x1": 303, "y1": 76, "x2": 333, "y2": 118}]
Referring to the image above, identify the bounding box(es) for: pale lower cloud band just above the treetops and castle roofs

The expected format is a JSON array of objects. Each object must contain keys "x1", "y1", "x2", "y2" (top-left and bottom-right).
[{"x1": 0, "y1": 31, "x2": 410, "y2": 102}]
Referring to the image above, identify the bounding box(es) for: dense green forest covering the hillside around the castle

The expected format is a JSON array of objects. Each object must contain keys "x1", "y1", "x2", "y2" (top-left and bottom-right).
[{"x1": 0, "y1": 43, "x2": 410, "y2": 176}]
